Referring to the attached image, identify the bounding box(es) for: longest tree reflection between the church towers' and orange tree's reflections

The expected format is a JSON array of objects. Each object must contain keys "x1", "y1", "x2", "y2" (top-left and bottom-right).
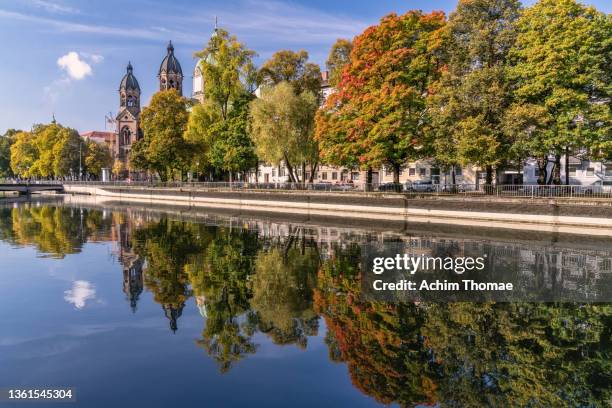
[{"x1": 185, "y1": 228, "x2": 259, "y2": 372}]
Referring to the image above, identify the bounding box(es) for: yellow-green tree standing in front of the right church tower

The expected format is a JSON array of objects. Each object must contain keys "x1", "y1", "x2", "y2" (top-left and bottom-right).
[{"x1": 139, "y1": 89, "x2": 192, "y2": 181}]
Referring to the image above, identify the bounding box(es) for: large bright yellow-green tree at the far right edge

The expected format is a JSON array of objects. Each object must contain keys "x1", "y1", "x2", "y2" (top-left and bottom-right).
[{"x1": 508, "y1": 0, "x2": 612, "y2": 184}]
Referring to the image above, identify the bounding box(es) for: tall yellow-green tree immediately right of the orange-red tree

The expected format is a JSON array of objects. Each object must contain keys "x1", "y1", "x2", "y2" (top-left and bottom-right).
[{"x1": 429, "y1": 0, "x2": 520, "y2": 184}]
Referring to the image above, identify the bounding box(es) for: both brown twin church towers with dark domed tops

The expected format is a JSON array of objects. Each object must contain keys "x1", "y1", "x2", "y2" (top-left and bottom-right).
[{"x1": 113, "y1": 41, "x2": 185, "y2": 162}]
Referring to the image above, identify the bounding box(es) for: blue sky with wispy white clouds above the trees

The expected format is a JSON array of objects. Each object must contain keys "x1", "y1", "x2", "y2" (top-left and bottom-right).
[{"x1": 0, "y1": 0, "x2": 612, "y2": 134}]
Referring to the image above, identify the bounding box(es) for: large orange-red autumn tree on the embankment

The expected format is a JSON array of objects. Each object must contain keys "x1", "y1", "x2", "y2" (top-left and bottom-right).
[{"x1": 316, "y1": 11, "x2": 445, "y2": 183}]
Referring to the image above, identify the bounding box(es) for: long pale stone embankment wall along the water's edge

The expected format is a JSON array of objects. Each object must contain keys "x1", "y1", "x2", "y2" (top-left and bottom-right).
[{"x1": 65, "y1": 185, "x2": 612, "y2": 235}]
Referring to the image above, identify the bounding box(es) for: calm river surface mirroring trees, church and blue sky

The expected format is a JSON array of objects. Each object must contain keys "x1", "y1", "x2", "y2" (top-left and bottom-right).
[{"x1": 0, "y1": 198, "x2": 612, "y2": 408}]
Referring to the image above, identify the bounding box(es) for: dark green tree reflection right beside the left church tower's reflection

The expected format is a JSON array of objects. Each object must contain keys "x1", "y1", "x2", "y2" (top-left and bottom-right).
[{"x1": 134, "y1": 218, "x2": 200, "y2": 331}]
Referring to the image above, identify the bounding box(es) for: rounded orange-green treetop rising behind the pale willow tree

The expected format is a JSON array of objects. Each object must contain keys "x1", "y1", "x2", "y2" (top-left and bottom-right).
[{"x1": 259, "y1": 50, "x2": 321, "y2": 96}]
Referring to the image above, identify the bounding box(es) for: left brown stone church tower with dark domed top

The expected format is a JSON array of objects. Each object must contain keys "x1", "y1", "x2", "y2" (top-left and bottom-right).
[{"x1": 115, "y1": 63, "x2": 140, "y2": 161}]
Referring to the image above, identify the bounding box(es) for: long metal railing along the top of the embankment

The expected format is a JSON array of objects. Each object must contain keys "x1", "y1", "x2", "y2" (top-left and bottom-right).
[{"x1": 0, "y1": 179, "x2": 612, "y2": 199}]
